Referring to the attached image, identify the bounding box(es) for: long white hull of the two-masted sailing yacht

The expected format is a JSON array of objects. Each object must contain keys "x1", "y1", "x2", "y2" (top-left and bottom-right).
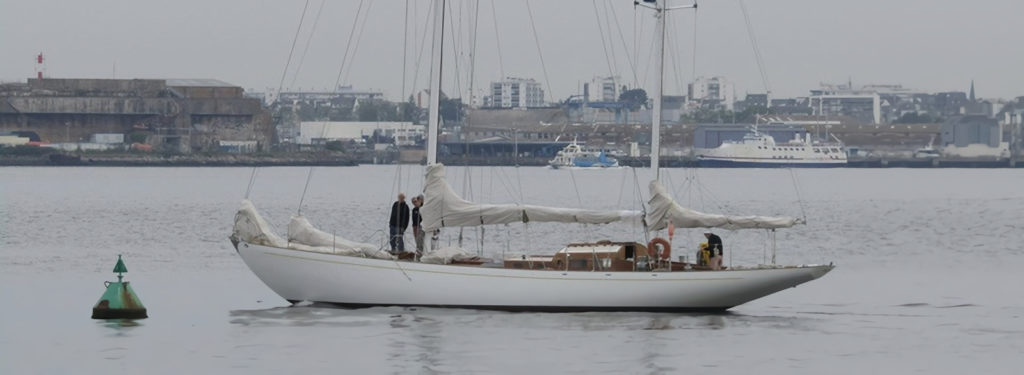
[{"x1": 237, "y1": 242, "x2": 834, "y2": 311}]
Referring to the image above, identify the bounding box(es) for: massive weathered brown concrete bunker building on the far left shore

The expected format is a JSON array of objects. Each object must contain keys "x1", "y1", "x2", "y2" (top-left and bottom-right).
[{"x1": 0, "y1": 78, "x2": 273, "y2": 153}]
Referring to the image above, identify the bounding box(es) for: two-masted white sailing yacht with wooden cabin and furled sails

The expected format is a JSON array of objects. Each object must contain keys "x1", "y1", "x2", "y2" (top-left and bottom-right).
[{"x1": 230, "y1": 0, "x2": 834, "y2": 311}]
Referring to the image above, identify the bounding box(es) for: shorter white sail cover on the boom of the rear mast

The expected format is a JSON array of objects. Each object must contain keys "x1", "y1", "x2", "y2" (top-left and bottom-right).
[{"x1": 647, "y1": 180, "x2": 804, "y2": 231}]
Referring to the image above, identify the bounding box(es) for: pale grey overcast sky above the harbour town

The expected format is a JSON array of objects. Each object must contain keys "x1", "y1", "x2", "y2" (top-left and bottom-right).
[{"x1": 0, "y1": 0, "x2": 1024, "y2": 99}]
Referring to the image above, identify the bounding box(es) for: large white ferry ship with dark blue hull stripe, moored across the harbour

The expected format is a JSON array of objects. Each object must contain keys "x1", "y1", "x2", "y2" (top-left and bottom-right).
[{"x1": 696, "y1": 128, "x2": 847, "y2": 168}]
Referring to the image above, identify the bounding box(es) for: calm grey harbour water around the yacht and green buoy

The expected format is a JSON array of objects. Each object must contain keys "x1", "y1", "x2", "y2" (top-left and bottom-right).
[{"x1": 0, "y1": 166, "x2": 1024, "y2": 374}]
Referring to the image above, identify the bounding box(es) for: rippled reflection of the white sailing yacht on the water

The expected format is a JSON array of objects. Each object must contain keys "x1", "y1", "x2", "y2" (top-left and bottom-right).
[{"x1": 229, "y1": 304, "x2": 822, "y2": 373}]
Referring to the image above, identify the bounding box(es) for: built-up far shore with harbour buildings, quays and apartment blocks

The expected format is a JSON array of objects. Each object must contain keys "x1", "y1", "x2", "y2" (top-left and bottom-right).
[{"x1": 0, "y1": 78, "x2": 1024, "y2": 168}]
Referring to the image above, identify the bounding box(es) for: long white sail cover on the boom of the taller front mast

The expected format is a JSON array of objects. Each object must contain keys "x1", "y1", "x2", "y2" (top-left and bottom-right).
[{"x1": 420, "y1": 164, "x2": 640, "y2": 232}]
